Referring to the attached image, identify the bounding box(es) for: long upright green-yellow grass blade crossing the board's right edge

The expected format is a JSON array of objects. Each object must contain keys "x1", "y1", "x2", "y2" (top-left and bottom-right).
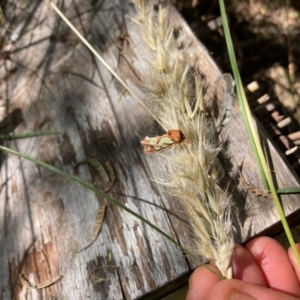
[{"x1": 219, "y1": 0, "x2": 300, "y2": 265}]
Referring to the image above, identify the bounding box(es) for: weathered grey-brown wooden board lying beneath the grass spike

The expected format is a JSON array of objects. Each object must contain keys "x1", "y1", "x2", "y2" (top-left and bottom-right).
[{"x1": 0, "y1": 1, "x2": 299, "y2": 299}]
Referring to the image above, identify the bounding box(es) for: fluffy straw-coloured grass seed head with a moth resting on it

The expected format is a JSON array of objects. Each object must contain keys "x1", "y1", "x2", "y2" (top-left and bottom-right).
[{"x1": 132, "y1": 0, "x2": 234, "y2": 278}]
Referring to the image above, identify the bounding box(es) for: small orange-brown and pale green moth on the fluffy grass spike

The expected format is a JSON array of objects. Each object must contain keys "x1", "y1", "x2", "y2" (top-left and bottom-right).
[{"x1": 141, "y1": 129, "x2": 185, "y2": 154}]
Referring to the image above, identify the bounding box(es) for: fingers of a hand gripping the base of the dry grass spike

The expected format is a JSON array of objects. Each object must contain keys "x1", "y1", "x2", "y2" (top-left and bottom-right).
[{"x1": 186, "y1": 237, "x2": 300, "y2": 300}]
